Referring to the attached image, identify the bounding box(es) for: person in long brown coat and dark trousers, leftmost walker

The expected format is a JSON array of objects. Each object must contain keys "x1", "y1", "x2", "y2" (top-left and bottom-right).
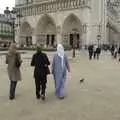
[{"x1": 6, "y1": 43, "x2": 22, "y2": 100}]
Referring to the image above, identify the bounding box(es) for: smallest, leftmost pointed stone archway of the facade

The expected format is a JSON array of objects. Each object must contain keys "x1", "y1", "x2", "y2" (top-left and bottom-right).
[{"x1": 20, "y1": 22, "x2": 32, "y2": 47}]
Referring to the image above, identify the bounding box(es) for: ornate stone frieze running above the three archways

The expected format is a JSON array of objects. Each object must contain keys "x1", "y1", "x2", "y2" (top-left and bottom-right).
[{"x1": 16, "y1": 0, "x2": 91, "y2": 16}]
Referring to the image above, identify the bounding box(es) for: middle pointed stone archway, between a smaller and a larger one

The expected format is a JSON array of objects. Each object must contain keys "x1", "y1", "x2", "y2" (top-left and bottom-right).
[{"x1": 36, "y1": 15, "x2": 56, "y2": 47}]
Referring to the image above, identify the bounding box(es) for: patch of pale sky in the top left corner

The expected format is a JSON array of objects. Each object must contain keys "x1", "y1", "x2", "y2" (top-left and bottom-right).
[{"x1": 0, "y1": 0, "x2": 15, "y2": 13}]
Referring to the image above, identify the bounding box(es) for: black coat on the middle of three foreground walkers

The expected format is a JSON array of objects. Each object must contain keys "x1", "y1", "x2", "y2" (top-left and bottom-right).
[{"x1": 31, "y1": 52, "x2": 50, "y2": 78}]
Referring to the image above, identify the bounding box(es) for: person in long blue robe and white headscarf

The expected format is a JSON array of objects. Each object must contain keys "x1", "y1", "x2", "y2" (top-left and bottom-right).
[{"x1": 52, "y1": 44, "x2": 70, "y2": 99}]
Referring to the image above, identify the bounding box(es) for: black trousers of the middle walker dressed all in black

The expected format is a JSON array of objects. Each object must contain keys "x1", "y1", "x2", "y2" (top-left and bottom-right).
[{"x1": 35, "y1": 75, "x2": 47, "y2": 96}]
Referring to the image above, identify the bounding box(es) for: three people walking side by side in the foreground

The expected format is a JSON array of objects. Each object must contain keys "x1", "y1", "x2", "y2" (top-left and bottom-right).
[{"x1": 6, "y1": 43, "x2": 70, "y2": 100}]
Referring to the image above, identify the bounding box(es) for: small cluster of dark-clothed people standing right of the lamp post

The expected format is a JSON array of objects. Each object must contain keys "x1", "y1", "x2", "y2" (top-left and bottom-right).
[{"x1": 88, "y1": 45, "x2": 101, "y2": 60}]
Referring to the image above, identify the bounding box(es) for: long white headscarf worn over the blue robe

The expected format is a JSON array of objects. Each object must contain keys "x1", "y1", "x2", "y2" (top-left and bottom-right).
[{"x1": 57, "y1": 44, "x2": 65, "y2": 67}]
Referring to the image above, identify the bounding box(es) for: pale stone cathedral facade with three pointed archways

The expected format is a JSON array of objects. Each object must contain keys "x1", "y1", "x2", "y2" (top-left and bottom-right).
[{"x1": 15, "y1": 0, "x2": 119, "y2": 47}]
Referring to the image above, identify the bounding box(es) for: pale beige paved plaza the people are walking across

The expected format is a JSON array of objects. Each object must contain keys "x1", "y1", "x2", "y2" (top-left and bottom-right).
[{"x1": 0, "y1": 51, "x2": 120, "y2": 120}]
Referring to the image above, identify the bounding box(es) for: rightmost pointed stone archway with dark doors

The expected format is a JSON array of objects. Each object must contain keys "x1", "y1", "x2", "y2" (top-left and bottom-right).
[{"x1": 62, "y1": 14, "x2": 82, "y2": 48}]
